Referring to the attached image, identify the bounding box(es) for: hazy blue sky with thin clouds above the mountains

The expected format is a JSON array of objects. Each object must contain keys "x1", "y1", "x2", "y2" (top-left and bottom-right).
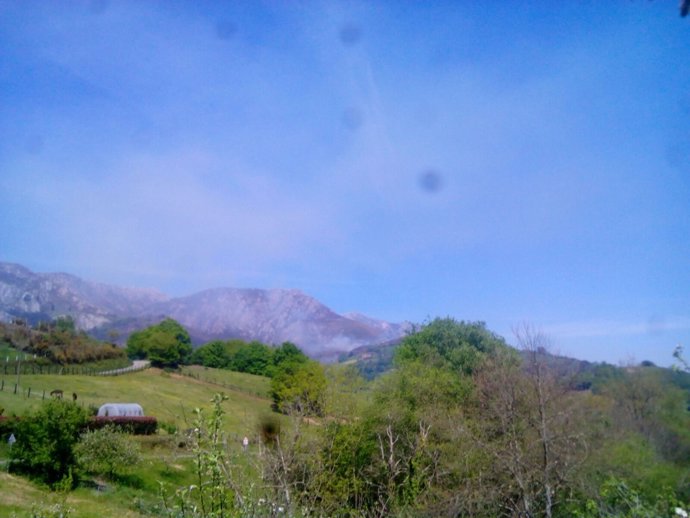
[{"x1": 0, "y1": 0, "x2": 690, "y2": 365}]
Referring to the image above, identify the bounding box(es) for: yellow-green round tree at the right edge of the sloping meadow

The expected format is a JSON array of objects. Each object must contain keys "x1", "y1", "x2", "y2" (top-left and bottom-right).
[{"x1": 271, "y1": 361, "x2": 326, "y2": 415}]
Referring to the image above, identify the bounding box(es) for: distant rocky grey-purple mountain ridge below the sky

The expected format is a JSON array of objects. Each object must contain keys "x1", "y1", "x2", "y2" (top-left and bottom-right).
[{"x1": 0, "y1": 262, "x2": 409, "y2": 359}]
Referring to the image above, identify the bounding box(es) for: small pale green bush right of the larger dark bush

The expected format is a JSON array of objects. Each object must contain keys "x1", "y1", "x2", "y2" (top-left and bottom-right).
[{"x1": 74, "y1": 426, "x2": 141, "y2": 480}]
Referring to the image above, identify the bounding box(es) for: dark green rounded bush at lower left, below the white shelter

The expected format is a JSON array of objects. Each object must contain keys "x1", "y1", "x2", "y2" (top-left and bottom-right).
[{"x1": 11, "y1": 399, "x2": 87, "y2": 485}]
